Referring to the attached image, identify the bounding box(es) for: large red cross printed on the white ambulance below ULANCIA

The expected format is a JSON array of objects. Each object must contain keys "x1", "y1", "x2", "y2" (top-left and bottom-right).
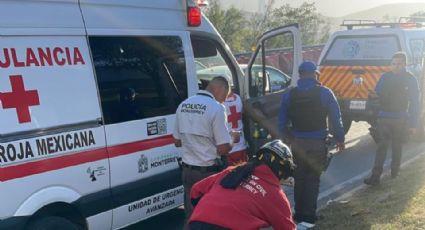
[{"x1": 0, "y1": 75, "x2": 40, "y2": 123}]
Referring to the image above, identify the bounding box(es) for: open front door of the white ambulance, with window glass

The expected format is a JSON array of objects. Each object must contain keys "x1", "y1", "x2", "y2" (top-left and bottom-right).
[{"x1": 244, "y1": 24, "x2": 302, "y2": 152}]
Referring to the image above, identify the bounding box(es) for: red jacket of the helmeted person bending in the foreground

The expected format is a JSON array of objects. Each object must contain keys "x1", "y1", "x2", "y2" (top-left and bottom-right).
[{"x1": 189, "y1": 165, "x2": 295, "y2": 230}]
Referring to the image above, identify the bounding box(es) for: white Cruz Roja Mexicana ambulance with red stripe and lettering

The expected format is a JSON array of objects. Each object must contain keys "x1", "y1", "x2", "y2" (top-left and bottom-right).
[{"x1": 0, "y1": 0, "x2": 301, "y2": 230}]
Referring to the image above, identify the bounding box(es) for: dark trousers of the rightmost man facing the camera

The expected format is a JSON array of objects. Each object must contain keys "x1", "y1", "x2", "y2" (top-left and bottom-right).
[{"x1": 372, "y1": 118, "x2": 407, "y2": 178}]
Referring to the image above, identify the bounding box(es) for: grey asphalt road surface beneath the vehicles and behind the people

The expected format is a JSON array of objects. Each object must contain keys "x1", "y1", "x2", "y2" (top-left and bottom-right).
[{"x1": 126, "y1": 122, "x2": 425, "y2": 230}]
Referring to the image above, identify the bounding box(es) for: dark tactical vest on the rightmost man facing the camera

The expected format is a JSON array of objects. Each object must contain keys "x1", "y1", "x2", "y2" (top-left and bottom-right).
[{"x1": 379, "y1": 73, "x2": 409, "y2": 112}]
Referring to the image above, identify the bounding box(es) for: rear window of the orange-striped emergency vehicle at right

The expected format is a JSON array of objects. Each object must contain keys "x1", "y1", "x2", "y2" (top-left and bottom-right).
[{"x1": 321, "y1": 35, "x2": 400, "y2": 65}]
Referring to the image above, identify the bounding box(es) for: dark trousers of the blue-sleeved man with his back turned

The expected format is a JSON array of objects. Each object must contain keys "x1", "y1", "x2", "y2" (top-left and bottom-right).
[{"x1": 291, "y1": 138, "x2": 327, "y2": 223}]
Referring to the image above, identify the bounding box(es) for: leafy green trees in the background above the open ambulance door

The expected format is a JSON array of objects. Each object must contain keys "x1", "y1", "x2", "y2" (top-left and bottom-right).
[{"x1": 204, "y1": 0, "x2": 330, "y2": 52}]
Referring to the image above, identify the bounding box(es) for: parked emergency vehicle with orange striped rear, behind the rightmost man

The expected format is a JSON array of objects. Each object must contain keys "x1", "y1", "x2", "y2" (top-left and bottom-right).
[{"x1": 319, "y1": 18, "x2": 425, "y2": 135}]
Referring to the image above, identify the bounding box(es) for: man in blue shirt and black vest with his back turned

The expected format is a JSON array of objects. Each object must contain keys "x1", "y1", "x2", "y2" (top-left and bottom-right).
[{"x1": 279, "y1": 61, "x2": 345, "y2": 223}]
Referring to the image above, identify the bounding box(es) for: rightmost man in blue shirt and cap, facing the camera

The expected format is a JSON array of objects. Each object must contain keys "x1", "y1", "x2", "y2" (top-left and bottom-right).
[{"x1": 364, "y1": 52, "x2": 419, "y2": 185}]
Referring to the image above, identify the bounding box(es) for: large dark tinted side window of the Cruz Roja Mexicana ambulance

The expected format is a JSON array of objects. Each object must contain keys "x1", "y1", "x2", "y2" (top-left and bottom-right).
[{"x1": 89, "y1": 36, "x2": 187, "y2": 124}]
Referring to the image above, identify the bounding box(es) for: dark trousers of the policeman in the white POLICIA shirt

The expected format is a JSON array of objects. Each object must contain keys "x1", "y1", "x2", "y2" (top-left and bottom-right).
[{"x1": 182, "y1": 167, "x2": 216, "y2": 226}]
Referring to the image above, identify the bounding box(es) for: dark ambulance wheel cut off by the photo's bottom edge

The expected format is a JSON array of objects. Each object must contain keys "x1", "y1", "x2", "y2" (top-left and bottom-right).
[{"x1": 28, "y1": 216, "x2": 81, "y2": 230}]
